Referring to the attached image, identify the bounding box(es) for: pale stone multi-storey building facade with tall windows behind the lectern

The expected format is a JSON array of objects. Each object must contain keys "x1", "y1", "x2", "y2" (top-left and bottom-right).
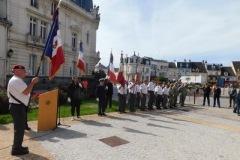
[{"x1": 0, "y1": 0, "x2": 100, "y2": 86}]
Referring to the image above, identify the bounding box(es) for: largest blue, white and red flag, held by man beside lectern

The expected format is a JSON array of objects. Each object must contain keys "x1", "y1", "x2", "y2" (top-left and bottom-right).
[{"x1": 44, "y1": 8, "x2": 65, "y2": 80}]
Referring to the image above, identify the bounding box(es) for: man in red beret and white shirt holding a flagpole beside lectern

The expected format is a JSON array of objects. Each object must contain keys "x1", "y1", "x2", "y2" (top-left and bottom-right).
[{"x1": 7, "y1": 65, "x2": 39, "y2": 155}]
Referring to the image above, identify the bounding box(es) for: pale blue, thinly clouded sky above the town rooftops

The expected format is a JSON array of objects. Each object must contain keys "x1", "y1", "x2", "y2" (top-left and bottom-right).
[{"x1": 93, "y1": 0, "x2": 240, "y2": 68}]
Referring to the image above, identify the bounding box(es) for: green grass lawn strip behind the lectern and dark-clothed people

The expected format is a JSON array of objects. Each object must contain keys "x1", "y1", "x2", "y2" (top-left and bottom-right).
[{"x1": 0, "y1": 99, "x2": 118, "y2": 124}]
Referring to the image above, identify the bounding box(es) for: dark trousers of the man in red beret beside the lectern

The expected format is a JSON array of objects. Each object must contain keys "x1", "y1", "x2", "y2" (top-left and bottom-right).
[{"x1": 9, "y1": 104, "x2": 26, "y2": 148}]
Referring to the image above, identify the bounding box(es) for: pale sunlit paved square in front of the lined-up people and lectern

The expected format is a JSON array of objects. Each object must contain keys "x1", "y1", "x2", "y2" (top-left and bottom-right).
[{"x1": 0, "y1": 97, "x2": 240, "y2": 160}]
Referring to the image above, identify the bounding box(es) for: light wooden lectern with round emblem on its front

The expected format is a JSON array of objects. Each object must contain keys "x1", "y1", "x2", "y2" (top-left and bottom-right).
[{"x1": 37, "y1": 89, "x2": 58, "y2": 131}]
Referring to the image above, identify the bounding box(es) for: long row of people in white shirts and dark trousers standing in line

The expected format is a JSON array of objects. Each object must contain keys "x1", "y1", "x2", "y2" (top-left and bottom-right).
[{"x1": 117, "y1": 79, "x2": 187, "y2": 113}]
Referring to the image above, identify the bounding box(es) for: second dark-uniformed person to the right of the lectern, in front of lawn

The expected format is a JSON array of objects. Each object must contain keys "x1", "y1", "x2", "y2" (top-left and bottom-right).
[{"x1": 96, "y1": 78, "x2": 107, "y2": 116}]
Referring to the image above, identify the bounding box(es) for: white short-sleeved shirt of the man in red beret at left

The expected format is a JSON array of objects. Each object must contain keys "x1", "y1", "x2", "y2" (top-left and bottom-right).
[{"x1": 7, "y1": 75, "x2": 30, "y2": 106}]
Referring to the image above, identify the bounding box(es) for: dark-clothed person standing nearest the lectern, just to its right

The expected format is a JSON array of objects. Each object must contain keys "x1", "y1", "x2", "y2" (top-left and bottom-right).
[{"x1": 68, "y1": 75, "x2": 83, "y2": 121}]
